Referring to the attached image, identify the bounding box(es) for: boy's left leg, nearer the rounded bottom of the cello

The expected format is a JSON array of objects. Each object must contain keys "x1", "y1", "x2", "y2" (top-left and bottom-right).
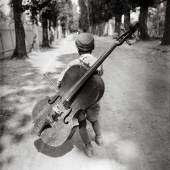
[{"x1": 79, "y1": 119, "x2": 94, "y2": 157}]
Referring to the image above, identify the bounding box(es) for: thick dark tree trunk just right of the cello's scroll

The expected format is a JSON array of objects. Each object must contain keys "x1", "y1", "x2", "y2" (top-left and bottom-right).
[{"x1": 139, "y1": 6, "x2": 149, "y2": 40}]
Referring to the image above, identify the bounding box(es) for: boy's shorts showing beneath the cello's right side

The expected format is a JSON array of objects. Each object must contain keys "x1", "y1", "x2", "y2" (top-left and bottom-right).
[{"x1": 75, "y1": 103, "x2": 100, "y2": 122}]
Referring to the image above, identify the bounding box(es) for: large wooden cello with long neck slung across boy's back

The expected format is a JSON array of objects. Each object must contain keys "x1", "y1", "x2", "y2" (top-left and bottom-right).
[{"x1": 32, "y1": 23, "x2": 139, "y2": 147}]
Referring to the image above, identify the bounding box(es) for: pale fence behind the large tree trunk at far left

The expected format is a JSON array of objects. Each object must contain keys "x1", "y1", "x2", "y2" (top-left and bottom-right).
[{"x1": 0, "y1": 23, "x2": 42, "y2": 58}]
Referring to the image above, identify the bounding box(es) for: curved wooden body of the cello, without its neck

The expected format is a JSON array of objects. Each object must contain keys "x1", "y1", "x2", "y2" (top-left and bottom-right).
[{"x1": 32, "y1": 65, "x2": 105, "y2": 147}]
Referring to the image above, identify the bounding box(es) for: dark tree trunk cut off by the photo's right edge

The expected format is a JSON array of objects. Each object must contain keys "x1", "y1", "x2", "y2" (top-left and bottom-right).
[{"x1": 162, "y1": 1, "x2": 170, "y2": 45}]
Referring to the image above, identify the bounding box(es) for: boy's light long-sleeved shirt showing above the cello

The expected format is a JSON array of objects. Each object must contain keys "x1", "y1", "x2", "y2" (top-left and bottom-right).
[{"x1": 58, "y1": 54, "x2": 103, "y2": 84}]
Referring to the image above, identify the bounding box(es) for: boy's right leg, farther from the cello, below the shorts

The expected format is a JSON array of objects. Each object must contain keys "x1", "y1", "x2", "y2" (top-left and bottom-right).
[{"x1": 91, "y1": 120, "x2": 103, "y2": 146}]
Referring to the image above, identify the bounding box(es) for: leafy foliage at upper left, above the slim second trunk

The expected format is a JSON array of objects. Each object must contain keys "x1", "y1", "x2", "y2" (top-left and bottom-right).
[{"x1": 24, "y1": 0, "x2": 73, "y2": 27}]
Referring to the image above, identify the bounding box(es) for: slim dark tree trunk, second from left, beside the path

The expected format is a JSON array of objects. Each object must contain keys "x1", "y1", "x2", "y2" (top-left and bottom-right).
[{"x1": 42, "y1": 17, "x2": 50, "y2": 47}]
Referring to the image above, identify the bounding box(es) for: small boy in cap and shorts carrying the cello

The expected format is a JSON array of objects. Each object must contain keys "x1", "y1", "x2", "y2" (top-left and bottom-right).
[{"x1": 58, "y1": 33, "x2": 103, "y2": 157}]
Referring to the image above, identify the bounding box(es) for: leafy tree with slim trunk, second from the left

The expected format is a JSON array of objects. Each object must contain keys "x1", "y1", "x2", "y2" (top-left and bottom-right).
[{"x1": 27, "y1": 0, "x2": 73, "y2": 47}]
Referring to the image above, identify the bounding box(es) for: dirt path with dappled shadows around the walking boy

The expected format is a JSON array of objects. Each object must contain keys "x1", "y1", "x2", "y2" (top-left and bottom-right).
[{"x1": 0, "y1": 37, "x2": 170, "y2": 170}]
